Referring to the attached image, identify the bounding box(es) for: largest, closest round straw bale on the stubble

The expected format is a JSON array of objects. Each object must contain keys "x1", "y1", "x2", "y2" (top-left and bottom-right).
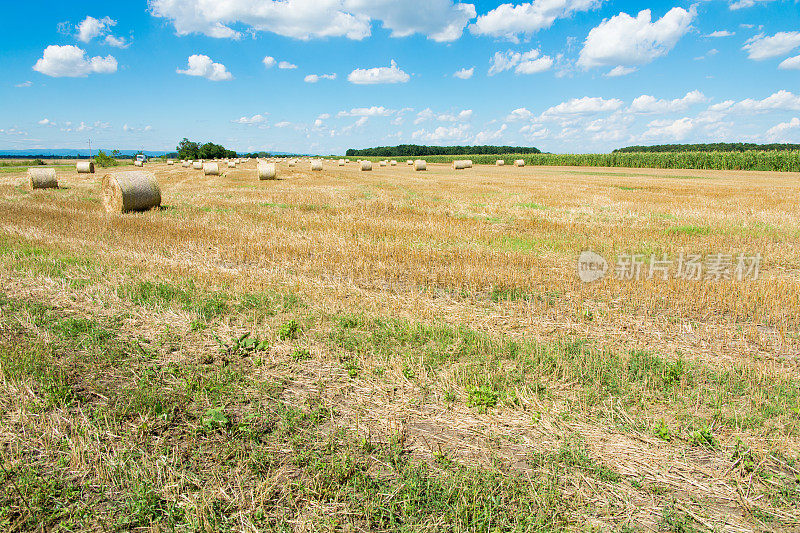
[{"x1": 102, "y1": 170, "x2": 161, "y2": 213}]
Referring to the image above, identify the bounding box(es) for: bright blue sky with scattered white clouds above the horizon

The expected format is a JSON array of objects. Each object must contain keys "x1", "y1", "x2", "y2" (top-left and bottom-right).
[{"x1": 0, "y1": 0, "x2": 800, "y2": 153}]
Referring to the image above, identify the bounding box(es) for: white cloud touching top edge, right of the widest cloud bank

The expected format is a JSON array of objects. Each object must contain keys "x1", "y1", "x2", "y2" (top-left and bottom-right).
[{"x1": 470, "y1": 0, "x2": 603, "y2": 41}]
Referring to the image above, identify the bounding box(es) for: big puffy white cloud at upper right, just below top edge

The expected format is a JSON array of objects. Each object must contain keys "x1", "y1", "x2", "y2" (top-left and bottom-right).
[{"x1": 578, "y1": 7, "x2": 696, "y2": 68}]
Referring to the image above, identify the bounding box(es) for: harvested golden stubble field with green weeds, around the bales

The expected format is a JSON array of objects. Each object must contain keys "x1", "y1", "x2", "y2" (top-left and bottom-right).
[{"x1": 0, "y1": 158, "x2": 800, "y2": 532}]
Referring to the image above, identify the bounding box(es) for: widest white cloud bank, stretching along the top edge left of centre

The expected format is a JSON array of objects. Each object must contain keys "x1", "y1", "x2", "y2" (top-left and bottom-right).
[{"x1": 149, "y1": 0, "x2": 476, "y2": 41}]
